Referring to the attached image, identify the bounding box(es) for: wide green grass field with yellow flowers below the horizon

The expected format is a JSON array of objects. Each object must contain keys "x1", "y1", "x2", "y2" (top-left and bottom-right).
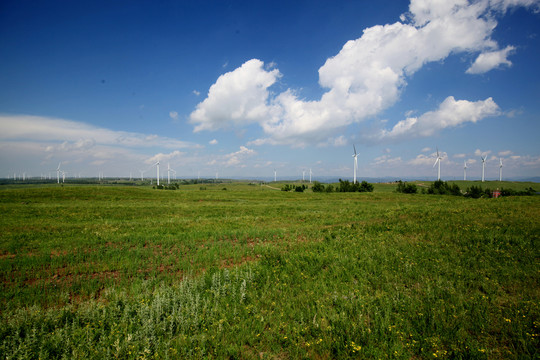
[{"x1": 0, "y1": 182, "x2": 540, "y2": 359}]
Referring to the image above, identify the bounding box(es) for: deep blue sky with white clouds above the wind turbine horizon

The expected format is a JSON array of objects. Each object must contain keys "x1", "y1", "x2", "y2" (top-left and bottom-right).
[{"x1": 0, "y1": 0, "x2": 540, "y2": 180}]
